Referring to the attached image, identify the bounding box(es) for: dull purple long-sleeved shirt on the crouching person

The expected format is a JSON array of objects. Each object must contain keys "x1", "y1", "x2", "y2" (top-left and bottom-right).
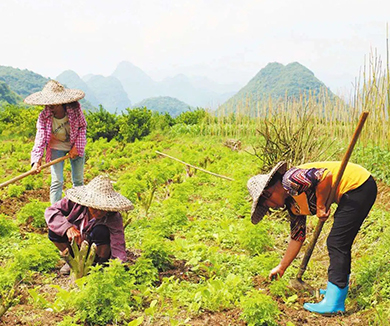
[{"x1": 45, "y1": 197, "x2": 127, "y2": 262}]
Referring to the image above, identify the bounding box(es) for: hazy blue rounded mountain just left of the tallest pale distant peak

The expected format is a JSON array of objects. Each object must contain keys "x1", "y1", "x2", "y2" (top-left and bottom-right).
[{"x1": 85, "y1": 75, "x2": 131, "y2": 113}]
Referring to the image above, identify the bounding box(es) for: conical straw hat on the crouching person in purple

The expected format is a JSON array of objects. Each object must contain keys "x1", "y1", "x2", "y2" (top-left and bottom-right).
[{"x1": 65, "y1": 176, "x2": 134, "y2": 212}]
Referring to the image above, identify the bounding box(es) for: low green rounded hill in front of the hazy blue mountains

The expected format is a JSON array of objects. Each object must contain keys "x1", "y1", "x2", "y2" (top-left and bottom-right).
[{"x1": 134, "y1": 96, "x2": 191, "y2": 117}]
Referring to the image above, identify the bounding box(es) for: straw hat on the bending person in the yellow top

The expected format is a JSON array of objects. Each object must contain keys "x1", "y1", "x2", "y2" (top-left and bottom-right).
[{"x1": 247, "y1": 161, "x2": 287, "y2": 224}]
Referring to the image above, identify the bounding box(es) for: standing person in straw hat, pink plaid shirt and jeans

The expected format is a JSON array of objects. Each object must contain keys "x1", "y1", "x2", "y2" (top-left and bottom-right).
[{"x1": 24, "y1": 80, "x2": 87, "y2": 204}]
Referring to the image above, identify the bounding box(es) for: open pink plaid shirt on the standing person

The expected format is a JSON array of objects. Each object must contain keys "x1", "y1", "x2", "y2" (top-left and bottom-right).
[{"x1": 31, "y1": 103, "x2": 87, "y2": 164}]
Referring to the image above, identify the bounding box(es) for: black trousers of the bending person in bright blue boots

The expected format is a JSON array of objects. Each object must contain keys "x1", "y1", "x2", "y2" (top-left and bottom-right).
[{"x1": 327, "y1": 176, "x2": 377, "y2": 288}]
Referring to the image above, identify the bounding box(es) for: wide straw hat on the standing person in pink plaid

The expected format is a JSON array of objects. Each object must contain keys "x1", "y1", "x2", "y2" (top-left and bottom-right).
[{"x1": 24, "y1": 80, "x2": 85, "y2": 105}]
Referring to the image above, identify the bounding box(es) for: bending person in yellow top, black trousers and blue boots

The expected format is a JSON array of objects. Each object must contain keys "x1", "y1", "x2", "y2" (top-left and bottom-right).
[{"x1": 248, "y1": 162, "x2": 377, "y2": 314}]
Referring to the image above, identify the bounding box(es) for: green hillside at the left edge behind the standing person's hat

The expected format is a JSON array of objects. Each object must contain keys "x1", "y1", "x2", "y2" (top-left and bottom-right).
[{"x1": 0, "y1": 66, "x2": 49, "y2": 99}]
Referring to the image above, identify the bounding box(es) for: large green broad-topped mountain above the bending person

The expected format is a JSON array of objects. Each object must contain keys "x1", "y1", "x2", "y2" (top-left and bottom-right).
[{"x1": 223, "y1": 62, "x2": 335, "y2": 108}]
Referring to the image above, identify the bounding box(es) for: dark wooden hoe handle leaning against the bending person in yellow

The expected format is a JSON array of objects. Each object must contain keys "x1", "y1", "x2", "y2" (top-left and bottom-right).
[{"x1": 297, "y1": 112, "x2": 368, "y2": 281}]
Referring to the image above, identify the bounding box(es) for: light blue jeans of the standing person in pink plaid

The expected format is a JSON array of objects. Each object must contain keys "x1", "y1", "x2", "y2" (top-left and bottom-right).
[{"x1": 50, "y1": 149, "x2": 85, "y2": 204}]
